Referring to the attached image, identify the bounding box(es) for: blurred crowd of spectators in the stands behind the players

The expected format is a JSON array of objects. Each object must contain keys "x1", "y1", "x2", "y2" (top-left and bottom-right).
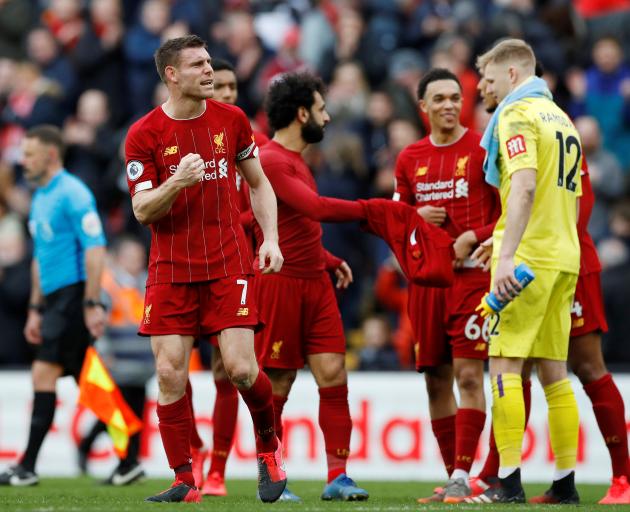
[{"x1": 0, "y1": 0, "x2": 630, "y2": 370}]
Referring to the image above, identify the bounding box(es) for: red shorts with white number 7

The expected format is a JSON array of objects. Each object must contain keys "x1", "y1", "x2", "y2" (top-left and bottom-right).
[{"x1": 138, "y1": 275, "x2": 259, "y2": 337}]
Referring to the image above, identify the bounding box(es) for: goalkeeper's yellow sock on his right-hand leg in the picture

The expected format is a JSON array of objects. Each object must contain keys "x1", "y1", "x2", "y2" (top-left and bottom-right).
[{"x1": 544, "y1": 379, "x2": 579, "y2": 471}]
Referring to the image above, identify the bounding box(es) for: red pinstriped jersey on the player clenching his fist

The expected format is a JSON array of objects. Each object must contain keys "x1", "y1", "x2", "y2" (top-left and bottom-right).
[{"x1": 125, "y1": 100, "x2": 258, "y2": 285}]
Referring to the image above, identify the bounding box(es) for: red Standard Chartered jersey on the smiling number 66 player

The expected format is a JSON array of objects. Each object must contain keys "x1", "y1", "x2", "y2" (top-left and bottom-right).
[{"x1": 394, "y1": 130, "x2": 501, "y2": 242}]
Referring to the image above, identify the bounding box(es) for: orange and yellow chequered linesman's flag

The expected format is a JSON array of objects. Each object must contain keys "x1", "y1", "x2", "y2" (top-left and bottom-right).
[{"x1": 79, "y1": 347, "x2": 142, "y2": 459}]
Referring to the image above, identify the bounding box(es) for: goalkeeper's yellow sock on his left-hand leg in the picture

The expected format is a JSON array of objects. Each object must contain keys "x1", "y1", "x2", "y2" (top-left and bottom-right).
[{"x1": 492, "y1": 373, "x2": 525, "y2": 476}]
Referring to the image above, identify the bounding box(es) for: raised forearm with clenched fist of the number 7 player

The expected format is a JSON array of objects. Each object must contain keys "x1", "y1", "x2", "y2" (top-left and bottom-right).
[{"x1": 131, "y1": 153, "x2": 205, "y2": 225}]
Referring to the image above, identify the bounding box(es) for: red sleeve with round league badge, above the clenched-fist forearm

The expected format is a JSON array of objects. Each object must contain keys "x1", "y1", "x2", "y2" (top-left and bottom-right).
[{"x1": 125, "y1": 125, "x2": 158, "y2": 197}]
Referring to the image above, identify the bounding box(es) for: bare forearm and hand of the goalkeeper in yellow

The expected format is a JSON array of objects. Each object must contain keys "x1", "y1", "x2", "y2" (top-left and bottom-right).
[{"x1": 493, "y1": 169, "x2": 536, "y2": 301}]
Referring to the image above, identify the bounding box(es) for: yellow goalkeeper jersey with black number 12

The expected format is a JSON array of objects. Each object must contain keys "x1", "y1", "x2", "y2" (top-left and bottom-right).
[{"x1": 493, "y1": 93, "x2": 582, "y2": 274}]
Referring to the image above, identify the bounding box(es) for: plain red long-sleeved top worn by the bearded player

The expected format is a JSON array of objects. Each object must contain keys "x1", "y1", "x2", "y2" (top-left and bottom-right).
[{"x1": 255, "y1": 140, "x2": 364, "y2": 278}]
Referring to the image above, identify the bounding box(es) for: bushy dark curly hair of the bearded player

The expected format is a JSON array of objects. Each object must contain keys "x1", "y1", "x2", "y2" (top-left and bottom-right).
[{"x1": 265, "y1": 72, "x2": 325, "y2": 130}]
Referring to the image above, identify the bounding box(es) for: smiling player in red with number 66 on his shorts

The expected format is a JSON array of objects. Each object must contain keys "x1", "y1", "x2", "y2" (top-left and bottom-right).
[{"x1": 394, "y1": 69, "x2": 499, "y2": 503}]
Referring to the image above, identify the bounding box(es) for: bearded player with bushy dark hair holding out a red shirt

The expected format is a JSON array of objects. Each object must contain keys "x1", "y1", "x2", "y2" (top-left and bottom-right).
[{"x1": 255, "y1": 73, "x2": 368, "y2": 500}]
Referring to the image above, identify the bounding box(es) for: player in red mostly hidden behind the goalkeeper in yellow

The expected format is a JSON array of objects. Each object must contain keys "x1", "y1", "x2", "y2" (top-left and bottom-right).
[{"x1": 471, "y1": 57, "x2": 630, "y2": 504}]
